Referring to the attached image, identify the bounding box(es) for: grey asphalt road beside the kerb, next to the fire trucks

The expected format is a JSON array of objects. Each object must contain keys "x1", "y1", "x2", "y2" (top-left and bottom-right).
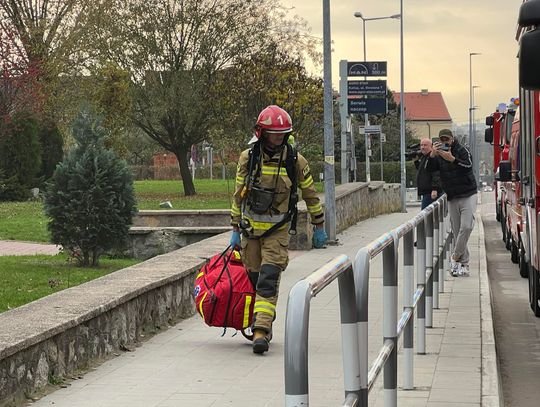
[{"x1": 482, "y1": 193, "x2": 540, "y2": 407}]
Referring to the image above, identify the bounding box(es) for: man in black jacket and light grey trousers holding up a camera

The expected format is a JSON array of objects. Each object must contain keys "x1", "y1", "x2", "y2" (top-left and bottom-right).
[{"x1": 427, "y1": 129, "x2": 478, "y2": 277}]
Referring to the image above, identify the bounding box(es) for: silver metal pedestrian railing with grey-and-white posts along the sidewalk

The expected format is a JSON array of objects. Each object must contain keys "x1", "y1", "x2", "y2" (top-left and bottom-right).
[{"x1": 284, "y1": 195, "x2": 452, "y2": 407}]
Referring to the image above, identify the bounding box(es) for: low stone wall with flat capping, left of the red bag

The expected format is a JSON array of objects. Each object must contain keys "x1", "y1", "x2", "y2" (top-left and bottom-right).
[{"x1": 0, "y1": 233, "x2": 229, "y2": 407}]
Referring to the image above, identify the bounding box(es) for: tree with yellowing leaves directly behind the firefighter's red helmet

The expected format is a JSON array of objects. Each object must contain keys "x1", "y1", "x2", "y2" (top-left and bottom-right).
[{"x1": 214, "y1": 43, "x2": 323, "y2": 164}]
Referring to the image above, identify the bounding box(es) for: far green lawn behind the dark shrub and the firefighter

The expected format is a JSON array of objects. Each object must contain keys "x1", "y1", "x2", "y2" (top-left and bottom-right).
[{"x1": 0, "y1": 179, "x2": 323, "y2": 242}]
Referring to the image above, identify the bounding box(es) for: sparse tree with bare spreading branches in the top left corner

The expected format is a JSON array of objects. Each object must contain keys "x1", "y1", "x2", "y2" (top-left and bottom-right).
[{"x1": 0, "y1": 0, "x2": 109, "y2": 122}]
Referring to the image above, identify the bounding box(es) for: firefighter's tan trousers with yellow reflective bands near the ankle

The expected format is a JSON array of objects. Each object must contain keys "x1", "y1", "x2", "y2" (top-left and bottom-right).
[{"x1": 242, "y1": 228, "x2": 289, "y2": 334}]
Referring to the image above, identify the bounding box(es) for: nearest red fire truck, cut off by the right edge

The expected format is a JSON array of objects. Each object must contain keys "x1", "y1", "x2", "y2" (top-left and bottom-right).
[{"x1": 499, "y1": 0, "x2": 540, "y2": 317}]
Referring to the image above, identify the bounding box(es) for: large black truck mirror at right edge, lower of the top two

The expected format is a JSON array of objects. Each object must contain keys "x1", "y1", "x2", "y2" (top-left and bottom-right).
[{"x1": 519, "y1": 29, "x2": 540, "y2": 90}]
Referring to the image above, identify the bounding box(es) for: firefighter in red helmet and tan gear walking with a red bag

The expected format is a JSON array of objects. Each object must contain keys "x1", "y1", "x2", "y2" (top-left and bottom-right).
[{"x1": 230, "y1": 105, "x2": 327, "y2": 354}]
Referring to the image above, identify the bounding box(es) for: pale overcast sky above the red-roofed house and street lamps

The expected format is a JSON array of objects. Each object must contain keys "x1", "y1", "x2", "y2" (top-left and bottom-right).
[{"x1": 282, "y1": 0, "x2": 522, "y2": 123}]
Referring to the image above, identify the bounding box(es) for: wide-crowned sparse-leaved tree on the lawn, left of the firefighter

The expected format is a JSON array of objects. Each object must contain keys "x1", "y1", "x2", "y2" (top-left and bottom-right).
[{"x1": 97, "y1": 0, "x2": 318, "y2": 195}]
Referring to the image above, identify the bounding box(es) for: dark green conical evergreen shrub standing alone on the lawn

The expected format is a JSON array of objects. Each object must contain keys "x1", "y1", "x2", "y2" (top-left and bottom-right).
[{"x1": 45, "y1": 111, "x2": 135, "y2": 266}]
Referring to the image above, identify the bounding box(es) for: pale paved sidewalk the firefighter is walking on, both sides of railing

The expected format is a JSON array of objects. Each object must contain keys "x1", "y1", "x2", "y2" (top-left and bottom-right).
[{"x1": 33, "y1": 204, "x2": 498, "y2": 407}]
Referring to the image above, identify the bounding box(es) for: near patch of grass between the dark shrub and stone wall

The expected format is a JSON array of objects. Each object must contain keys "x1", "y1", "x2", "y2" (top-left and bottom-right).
[{"x1": 0, "y1": 254, "x2": 139, "y2": 312}]
